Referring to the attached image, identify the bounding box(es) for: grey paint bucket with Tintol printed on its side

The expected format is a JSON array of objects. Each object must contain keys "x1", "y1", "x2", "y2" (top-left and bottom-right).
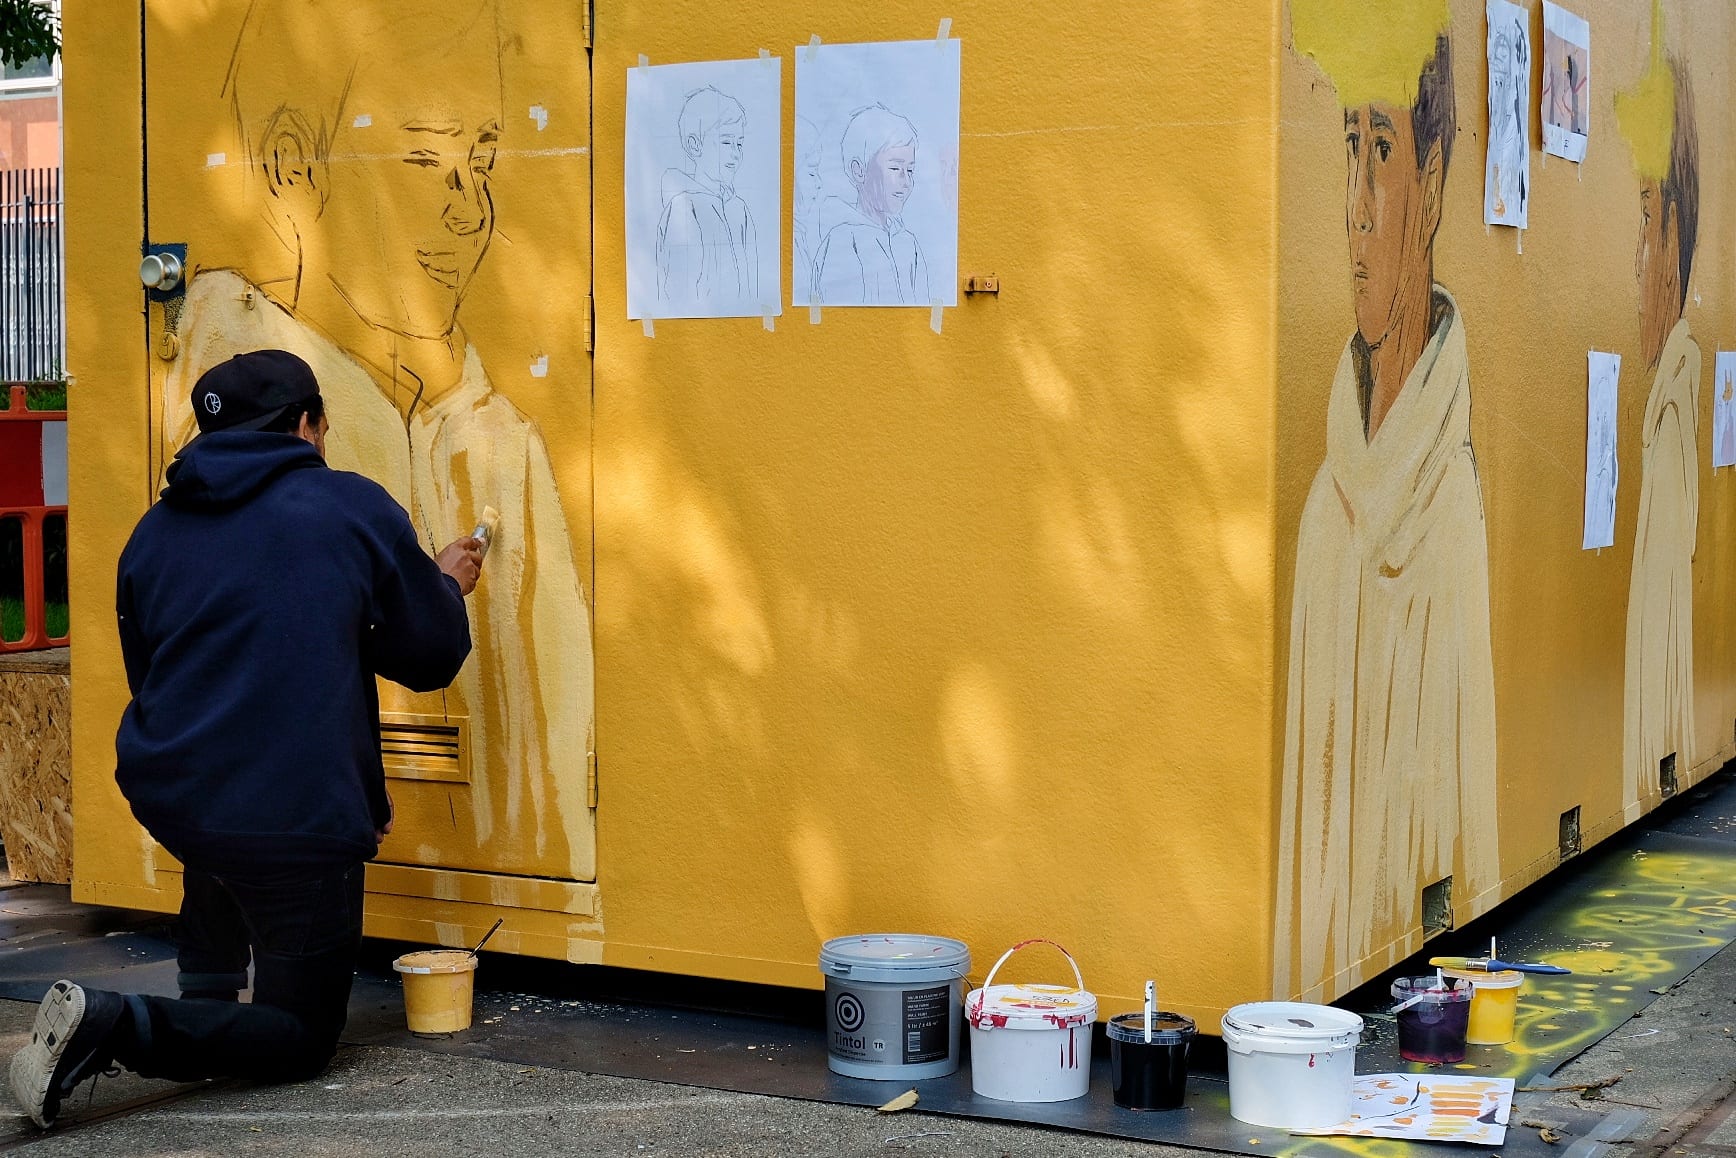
[{"x1": 819, "y1": 932, "x2": 970, "y2": 1082}]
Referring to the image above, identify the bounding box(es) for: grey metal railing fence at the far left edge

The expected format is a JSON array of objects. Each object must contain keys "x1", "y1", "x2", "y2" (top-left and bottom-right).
[{"x1": 0, "y1": 168, "x2": 66, "y2": 382}]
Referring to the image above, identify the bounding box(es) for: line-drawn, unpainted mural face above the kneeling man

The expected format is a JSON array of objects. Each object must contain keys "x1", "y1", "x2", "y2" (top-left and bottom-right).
[{"x1": 312, "y1": 45, "x2": 500, "y2": 339}]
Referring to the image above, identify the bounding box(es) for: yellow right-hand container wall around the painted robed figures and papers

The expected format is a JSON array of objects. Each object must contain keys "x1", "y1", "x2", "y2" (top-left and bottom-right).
[{"x1": 1272, "y1": 0, "x2": 1736, "y2": 988}]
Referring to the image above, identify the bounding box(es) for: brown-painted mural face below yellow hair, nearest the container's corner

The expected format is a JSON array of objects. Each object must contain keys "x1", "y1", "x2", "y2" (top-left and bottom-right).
[{"x1": 1344, "y1": 104, "x2": 1437, "y2": 347}]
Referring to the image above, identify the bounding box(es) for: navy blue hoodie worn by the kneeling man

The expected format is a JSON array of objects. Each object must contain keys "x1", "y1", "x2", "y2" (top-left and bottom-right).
[{"x1": 115, "y1": 431, "x2": 470, "y2": 872}]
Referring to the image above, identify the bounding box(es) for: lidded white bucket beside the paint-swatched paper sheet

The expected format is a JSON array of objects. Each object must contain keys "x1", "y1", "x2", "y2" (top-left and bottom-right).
[{"x1": 1222, "y1": 1002, "x2": 1363, "y2": 1130}]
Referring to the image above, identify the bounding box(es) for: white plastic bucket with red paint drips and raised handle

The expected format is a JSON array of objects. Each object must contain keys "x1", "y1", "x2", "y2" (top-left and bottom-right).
[{"x1": 965, "y1": 938, "x2": 1097, "y2": 1102}]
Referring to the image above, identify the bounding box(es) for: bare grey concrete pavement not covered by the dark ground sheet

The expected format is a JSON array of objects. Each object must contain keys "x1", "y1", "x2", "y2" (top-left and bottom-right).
[{"x1": 0, "y1": 930, "x2": 1736, "y2": 1158}]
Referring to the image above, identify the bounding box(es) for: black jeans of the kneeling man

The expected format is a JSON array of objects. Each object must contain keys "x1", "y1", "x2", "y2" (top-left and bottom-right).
[{"x1": 102, "y1": 865, "x2": 363, "y2": 1082}]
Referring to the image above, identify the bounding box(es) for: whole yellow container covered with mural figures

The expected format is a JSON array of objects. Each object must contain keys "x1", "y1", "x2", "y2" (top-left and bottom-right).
[{"x1": 54, "y1": 0, "x2": 1736, "y2": 1028}]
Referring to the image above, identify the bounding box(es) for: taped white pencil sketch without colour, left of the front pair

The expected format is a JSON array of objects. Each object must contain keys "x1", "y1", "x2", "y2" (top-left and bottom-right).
[{"x1": 627, "y1": 57, "x2": 783, "y2": 318}]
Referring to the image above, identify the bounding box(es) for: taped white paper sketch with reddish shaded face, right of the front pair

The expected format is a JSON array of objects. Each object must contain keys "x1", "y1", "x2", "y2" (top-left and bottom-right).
[{"x1": 790, "y1": 40, "x2": 960, "y2": 306}]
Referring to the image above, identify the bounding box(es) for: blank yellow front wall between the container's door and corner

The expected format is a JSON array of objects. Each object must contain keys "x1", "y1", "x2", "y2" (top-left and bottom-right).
[{"x1": 595, "y1": 2, "x2": 1276, "y2": 1012}]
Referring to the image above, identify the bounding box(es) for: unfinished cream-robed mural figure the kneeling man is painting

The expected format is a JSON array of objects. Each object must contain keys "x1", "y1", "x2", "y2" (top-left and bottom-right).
[{"x1": 163, "y1": 0, "x2": 595, "y2": 880}]
